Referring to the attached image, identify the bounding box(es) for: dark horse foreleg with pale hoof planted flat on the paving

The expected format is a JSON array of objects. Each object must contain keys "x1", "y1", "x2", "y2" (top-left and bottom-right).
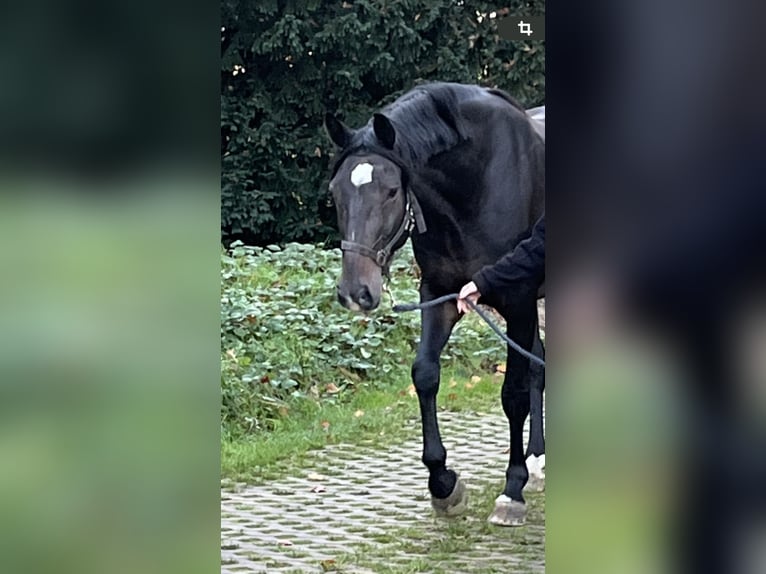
[{"x1": 489, "y1": 309, "x2": 536, "y2": 526}]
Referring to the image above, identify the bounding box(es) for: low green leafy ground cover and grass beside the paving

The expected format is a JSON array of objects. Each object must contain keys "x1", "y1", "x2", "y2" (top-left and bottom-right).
[{"x1": 221, "y1": 242, "x2": 503, "y2": 433}]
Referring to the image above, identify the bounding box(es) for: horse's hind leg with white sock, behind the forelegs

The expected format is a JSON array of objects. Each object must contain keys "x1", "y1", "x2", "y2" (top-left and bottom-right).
[{"x1": 526, "y1": 331, "x2": 545, "y2": 492}]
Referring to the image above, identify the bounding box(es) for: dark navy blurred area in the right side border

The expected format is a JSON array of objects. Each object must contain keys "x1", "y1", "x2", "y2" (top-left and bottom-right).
[{"x1": 547, "y1": 1, "x2": 766, "y2": 573}]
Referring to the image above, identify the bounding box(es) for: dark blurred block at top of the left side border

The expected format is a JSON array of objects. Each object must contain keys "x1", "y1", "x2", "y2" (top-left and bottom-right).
[{"x1": 0, "y1": 2, "x2": 218, "y2": 177}]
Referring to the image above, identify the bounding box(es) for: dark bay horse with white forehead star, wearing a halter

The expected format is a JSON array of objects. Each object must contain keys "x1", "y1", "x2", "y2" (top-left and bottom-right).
[{"x1": 325, "y1": 83, "x2": 545, "y2": 526}]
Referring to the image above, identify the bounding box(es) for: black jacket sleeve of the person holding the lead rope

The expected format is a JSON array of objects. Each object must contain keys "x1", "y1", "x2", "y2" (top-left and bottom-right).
[{"x1": 472, "y1": 214, "x2": 545, "y2": 297}]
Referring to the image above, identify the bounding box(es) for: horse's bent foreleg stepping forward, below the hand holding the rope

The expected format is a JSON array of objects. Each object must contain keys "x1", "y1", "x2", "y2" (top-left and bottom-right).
[{"x1": 412, "y1": 293, "x2": 466, "y2": 514}]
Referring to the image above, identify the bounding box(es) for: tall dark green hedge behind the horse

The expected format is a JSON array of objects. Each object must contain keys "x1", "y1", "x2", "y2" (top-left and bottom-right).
[{"x1": 221, "y1": 0, "x2": 545, "y2": 245}]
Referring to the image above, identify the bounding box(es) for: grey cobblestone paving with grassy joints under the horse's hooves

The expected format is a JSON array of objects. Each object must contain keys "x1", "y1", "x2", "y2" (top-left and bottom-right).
[{"x1": 221, "y1": 413, "x2": 545, "y2": 573}]
